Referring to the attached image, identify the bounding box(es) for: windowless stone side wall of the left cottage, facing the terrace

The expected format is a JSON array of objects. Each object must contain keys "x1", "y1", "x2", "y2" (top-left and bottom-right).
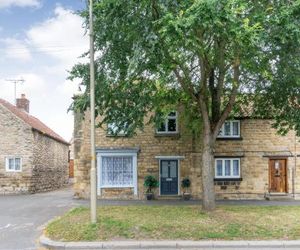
[{"x1": 30, "y1": 131, "x2": 69, "y2": 192}]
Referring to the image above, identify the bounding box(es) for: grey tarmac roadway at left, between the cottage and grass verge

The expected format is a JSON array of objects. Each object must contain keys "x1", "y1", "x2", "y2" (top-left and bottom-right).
[{"x1": 0, "y1": 188, "x2": 83, "y2": 250}]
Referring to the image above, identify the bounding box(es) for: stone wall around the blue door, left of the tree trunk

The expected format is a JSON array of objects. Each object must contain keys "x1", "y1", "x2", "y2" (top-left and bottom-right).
[{"x1": 74, "y1": 113, "x2": 200, "y2": 199}]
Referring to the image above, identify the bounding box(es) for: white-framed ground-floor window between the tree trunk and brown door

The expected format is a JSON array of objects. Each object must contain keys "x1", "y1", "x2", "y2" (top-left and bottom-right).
[{"x1": 215, "y1": 158, "x2": 241, "y2": 178}]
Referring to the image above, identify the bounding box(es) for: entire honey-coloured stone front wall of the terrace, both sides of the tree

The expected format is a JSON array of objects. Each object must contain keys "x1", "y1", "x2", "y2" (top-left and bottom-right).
[{"x1": 74, "y1": 109, "x2": 300, "y2": 199}]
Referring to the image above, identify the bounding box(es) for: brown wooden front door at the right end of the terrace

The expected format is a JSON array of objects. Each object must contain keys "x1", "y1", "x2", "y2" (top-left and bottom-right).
[{"x1": 269, "y1": 159, "x2": 287, "y2": 193}]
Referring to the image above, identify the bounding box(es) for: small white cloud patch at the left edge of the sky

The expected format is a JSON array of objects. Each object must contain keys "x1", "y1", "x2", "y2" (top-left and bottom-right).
[{"x1": 0, "y1": 38, "x2": 32, "y2": 62}]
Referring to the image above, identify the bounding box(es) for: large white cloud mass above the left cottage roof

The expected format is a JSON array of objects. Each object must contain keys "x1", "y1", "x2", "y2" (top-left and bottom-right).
[{"x1": 0, "y1": 5, "x2": 89, "y2": 139}]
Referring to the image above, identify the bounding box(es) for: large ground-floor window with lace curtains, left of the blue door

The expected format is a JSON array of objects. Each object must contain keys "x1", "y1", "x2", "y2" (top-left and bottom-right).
[{"x1": 97, "y1": 151, "x2": 137, "y2": 195}]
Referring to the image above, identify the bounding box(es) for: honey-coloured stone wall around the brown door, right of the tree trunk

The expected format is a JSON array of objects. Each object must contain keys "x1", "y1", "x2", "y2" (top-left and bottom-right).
[{"x1": 215, "y1": 119, "x2": 300, "y2": 199}]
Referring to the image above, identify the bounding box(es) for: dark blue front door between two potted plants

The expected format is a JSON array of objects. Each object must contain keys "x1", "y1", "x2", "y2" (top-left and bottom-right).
[{"x1": 160, "y1": 160, "x2": 178, "y2": 195}]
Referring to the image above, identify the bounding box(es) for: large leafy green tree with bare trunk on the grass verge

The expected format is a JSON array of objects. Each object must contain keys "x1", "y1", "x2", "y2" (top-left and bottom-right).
[{"x1": 70, "y1": 0, "x2": 300, "y2": 210}]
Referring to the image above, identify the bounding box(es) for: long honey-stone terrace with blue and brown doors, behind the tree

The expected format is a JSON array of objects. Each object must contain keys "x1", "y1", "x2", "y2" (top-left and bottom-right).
[{"x1": 74, "y1": 109, "x2": 300, "y2": 199}]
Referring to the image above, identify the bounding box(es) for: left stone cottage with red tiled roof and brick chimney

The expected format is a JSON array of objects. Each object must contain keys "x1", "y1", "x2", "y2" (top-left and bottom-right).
[{"x1": 0, "y1": 95, "x2": 69, "y2": 194}]
